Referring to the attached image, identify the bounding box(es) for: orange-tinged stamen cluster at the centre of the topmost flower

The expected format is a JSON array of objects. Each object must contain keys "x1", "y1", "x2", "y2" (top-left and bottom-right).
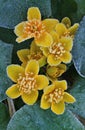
[{"x1": 24, "y1": 19, "x2": 45, "y2": 38}]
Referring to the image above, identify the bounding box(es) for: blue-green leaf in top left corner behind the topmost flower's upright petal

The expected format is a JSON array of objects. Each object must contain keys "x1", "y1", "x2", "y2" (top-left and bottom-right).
[{"x1": 0, "y1": 0, "x2": 51, "y2": 28}]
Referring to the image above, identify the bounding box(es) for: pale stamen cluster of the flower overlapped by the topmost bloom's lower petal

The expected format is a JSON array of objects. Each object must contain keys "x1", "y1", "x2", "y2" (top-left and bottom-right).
[{"x1": 49, "y1": 43, "x2": 65, "y2": 59}]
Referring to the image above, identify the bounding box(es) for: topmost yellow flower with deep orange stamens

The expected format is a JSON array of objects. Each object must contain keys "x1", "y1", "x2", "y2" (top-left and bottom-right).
[{"x1": 14, "y1": 7, "x2": 58, "y2": 47}]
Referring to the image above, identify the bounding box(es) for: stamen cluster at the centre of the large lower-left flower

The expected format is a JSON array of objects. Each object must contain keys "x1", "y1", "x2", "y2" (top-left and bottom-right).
[{"x1": 17, "y1": 72, "x2": 36, "y2": 94}]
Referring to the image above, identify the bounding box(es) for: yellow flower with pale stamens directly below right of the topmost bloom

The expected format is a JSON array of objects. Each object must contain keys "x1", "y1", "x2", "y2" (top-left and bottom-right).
[{"x1": 41, "y1": 35, "x2": 73, "y2": 66}]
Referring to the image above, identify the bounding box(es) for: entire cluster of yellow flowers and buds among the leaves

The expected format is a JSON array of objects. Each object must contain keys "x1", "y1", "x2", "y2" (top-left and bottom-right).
[{"x1": 6, "y1": 7, "x2": 79, "y2": 114}]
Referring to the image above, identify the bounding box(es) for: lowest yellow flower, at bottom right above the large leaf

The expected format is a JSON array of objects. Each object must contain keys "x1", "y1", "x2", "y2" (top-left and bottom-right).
[{"x1": 40, "y1": 80, "x2": 75, "y2": 114}]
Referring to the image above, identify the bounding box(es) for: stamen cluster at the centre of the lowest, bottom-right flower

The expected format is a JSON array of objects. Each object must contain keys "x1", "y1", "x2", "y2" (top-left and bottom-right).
[{"x1": 45, "y1": 88, "x2": 64, "y2": 103}]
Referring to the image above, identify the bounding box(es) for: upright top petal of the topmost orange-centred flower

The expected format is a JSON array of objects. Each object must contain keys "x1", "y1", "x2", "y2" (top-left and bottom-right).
[{"x1": 27, "y1": 7, "x2": 41, "y2": 20}]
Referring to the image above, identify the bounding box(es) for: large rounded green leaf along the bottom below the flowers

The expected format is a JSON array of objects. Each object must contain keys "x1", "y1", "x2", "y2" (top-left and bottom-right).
[{"x1": 7, "y1": 104, "x2": 85, "y2": 130}]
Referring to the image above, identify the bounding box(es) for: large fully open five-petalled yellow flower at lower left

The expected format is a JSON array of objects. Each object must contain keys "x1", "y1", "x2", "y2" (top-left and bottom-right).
[{"x1": 6, "y1": 60, "x2": 49, "y2": 105}]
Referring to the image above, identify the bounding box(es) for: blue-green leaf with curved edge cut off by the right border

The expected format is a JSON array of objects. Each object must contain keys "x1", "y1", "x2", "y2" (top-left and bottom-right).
[{"x1": 72, "y1": 17, "x2": 85, "y2": 77}]
